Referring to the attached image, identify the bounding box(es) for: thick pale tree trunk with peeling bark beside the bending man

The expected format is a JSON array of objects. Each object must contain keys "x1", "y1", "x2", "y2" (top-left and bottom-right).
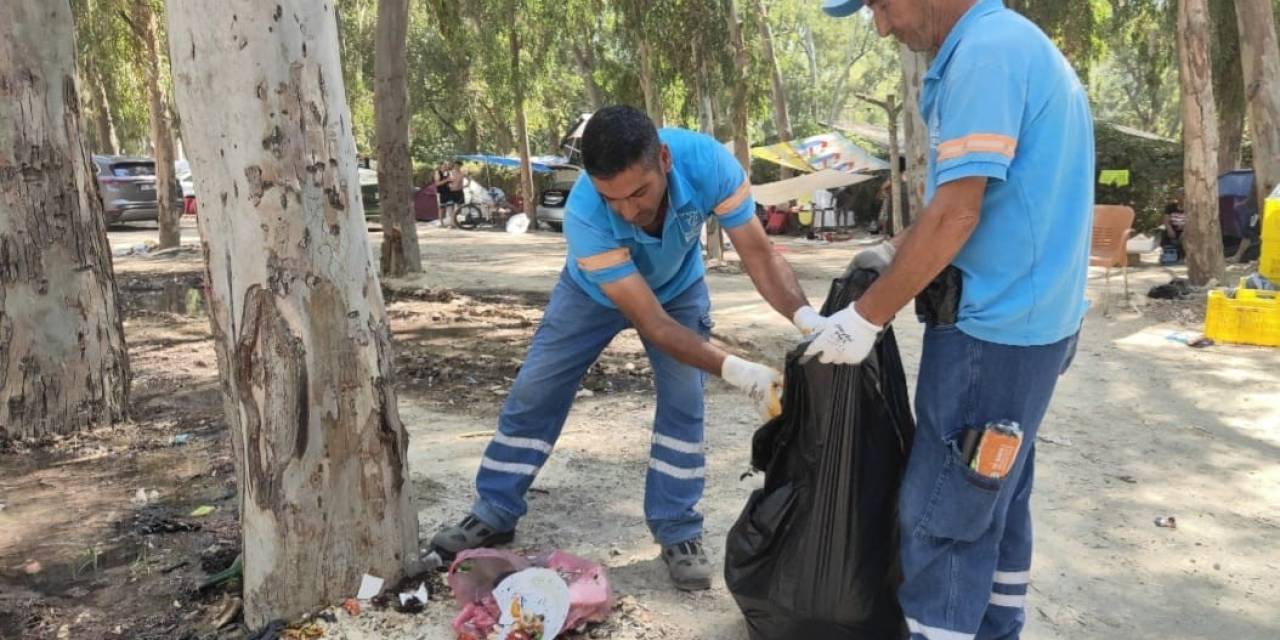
[{"x1": 169, "y1": 0, "x2": 417, "y2": 627}]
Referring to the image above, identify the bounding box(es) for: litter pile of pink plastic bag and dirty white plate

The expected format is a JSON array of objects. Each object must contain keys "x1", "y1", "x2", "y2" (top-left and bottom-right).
[{"x1": 448, "y1": 549, "x2": 613, "y2": 640}]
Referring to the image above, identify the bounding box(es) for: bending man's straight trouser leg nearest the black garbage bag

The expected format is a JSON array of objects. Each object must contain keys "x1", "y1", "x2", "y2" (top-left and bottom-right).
[{"x1": 644, "y1": 280, "x2": 710, "y2": 545}]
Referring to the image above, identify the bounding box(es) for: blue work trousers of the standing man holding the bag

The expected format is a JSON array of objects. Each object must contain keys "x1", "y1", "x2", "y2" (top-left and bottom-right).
[{"x1": 899, "y1": 325, "x2": 1078, "y2": 640}]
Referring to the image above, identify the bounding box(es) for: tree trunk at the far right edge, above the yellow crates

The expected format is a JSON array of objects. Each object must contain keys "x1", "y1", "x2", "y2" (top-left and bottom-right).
[{"x1": 1235, "y1": 0, "x2": 1280, "y2": 202}]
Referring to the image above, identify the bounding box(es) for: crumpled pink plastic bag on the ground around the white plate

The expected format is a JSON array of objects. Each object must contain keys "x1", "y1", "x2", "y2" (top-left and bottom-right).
[{"x1": 448, "y1": 549, "x2": 613, "y2": 640}]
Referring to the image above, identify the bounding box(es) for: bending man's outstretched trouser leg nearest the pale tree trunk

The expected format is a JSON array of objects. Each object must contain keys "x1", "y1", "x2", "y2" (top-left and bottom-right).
[{"x1": 471, "y1": 274, "x2": 626, "y2": 531}]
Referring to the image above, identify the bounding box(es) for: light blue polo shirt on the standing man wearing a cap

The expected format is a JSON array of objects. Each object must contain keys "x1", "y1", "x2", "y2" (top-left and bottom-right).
[{"x1": 920, "y1": 0, "x2": 1094, "y2": 346}]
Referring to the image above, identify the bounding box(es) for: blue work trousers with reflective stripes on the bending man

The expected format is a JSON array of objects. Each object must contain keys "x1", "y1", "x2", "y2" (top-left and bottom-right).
[{"x1": 472, "y1": 274, "x2": 712, "y2": 545}]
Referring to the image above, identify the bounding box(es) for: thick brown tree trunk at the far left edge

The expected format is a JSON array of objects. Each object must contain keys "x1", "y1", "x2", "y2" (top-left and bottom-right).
[{"x1": 0, "y1": 0, "x2": 129, "y2": 439}]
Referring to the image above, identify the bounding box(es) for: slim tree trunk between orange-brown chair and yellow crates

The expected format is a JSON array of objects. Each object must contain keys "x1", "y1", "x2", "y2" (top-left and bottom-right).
[{"x1": 1178, "y1": 0, "x2": 1226, "y2": 284}]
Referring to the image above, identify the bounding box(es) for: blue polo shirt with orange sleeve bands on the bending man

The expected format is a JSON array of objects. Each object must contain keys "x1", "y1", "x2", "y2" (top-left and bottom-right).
[{"x1": 564, "y1": 129, "x2": 755, "y2": 308}]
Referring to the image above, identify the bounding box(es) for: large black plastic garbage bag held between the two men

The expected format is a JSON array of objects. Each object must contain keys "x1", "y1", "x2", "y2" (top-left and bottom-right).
[{"x1": 724, "y1": 271, "x2": 915, "y2": 640}]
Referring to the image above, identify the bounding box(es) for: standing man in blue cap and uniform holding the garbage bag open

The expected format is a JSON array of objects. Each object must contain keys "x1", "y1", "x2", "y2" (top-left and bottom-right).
[{"x1": 808, "y1": 0, "x2": 1094, "y2": 640}]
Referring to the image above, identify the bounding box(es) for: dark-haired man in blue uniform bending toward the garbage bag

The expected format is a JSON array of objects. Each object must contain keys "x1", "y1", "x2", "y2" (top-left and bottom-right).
[{"x1": 431, "y1": 106, "x2": 826, "y2": 590}]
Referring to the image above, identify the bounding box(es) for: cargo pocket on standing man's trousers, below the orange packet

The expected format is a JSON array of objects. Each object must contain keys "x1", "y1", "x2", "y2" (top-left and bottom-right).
[{"x1": 914, "y1": 444, "x2": 1004, "y2": 543}]
